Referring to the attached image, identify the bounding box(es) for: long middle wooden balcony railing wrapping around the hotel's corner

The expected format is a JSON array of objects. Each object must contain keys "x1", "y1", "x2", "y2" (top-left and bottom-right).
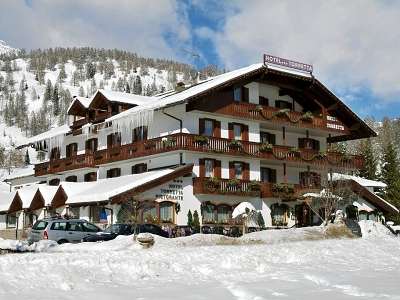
[{"x1": 35, "y1": 133, "x2": 364, "y2": 176}]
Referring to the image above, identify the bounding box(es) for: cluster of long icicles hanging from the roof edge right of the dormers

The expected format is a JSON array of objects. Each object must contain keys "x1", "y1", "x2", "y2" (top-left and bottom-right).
[{"x1": 112, "y1": 108, "x2": 154, "y2": 133}]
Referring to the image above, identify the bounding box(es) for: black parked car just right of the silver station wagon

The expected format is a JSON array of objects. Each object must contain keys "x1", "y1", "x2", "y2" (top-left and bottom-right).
[{"x1": 83, "y1": 223, "x2": 168, "y2": 242}]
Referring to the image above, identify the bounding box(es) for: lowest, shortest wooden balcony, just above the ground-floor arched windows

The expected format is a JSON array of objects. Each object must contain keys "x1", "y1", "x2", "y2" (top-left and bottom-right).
[{"x1": 193, "y1": 177, "x2": 304, "y2": 199}]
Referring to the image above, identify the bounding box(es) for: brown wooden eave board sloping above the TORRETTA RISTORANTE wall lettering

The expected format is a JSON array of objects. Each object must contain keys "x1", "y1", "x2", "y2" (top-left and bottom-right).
[{"x1": 110, "y1": 164, "x2": 194, "y2": 204}]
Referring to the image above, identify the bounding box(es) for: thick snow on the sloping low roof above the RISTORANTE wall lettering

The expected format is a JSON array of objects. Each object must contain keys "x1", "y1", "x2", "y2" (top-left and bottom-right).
[{"x1": 62, "y1": 169, "x2": 174, "y2": 204}]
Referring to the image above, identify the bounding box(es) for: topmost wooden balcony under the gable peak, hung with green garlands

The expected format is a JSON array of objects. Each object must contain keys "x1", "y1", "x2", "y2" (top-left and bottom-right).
[{"x1": 209, "y1": 102, "x2": 350, "y2": 134}]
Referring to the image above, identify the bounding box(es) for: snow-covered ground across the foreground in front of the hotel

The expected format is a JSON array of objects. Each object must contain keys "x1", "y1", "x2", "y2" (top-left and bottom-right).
[{"x1": 0, "y1": 221, "x2": 400, "y2": 300}]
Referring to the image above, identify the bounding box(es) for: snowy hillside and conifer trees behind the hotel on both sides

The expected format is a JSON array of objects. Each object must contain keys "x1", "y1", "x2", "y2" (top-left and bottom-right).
[{"x1": 0, "y1": 41, "x2": 400, "y2": 223}]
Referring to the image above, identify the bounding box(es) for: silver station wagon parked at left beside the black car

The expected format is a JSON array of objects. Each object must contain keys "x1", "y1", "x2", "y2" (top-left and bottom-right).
[{"x1": 28, "y1": 219, "x2": 102, "y2": 244}]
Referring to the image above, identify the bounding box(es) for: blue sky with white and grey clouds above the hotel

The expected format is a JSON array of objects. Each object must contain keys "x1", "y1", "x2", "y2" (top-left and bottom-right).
[{"x1": 0, "y1": 0, "x2": 400, "y2": 121}]
